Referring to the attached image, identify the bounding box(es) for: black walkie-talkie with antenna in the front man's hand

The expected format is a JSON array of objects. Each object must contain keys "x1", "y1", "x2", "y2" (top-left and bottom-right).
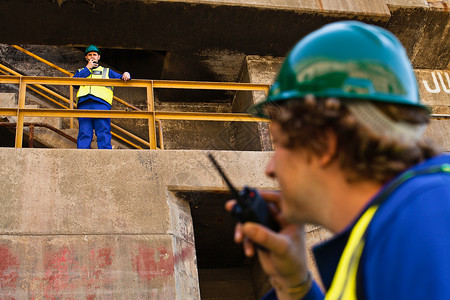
[{"x1": 208, "y1": 153, "x2": 279, "y2": 232}]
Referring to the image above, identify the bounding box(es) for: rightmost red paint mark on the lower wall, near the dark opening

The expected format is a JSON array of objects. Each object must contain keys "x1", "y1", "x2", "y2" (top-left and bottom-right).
[{"x1": 132, "y1": 246, "x2": 174, "y2": 281}]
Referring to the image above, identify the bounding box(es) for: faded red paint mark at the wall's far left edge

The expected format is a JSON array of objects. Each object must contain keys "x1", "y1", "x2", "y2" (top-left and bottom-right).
[{"x1": 0, "y1": 246, "x2": 20, "y2": 299}]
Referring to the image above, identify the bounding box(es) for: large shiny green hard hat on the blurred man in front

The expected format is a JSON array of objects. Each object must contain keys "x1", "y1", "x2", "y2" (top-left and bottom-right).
[{"x1": 252, "y1": 21, "x2": 423, "y2": 117}]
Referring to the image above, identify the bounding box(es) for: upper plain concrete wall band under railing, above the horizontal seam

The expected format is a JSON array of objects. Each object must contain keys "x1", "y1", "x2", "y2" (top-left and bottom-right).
[{"x1": 0, "y1": 148, "x2": 274, "y2": 235}]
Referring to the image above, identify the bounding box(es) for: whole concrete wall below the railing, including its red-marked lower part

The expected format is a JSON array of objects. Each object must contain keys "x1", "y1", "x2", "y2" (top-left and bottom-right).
[{"x1": 0, "y1": 148, "x2": 275, "y2": 299}]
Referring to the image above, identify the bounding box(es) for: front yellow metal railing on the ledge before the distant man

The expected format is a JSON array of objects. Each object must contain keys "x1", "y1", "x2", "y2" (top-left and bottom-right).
[{"x1": 0, "y1": 75, "x2": 269, "y2": 149}]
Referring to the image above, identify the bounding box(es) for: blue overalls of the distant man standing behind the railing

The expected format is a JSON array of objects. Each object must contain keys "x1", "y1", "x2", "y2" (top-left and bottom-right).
[{"x1": 73, "y1": 67, "x2": 126, "y2": 149}]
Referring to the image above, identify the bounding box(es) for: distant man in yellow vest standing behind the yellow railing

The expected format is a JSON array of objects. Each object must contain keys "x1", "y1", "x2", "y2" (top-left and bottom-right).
[{"x1": 73, "y1": 45, "x2": 131, "y2": 149}]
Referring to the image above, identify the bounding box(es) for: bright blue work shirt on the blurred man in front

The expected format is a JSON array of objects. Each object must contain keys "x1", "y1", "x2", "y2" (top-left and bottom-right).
[{"x1": 263, "y1": 154, "x2": 450, "y2": 300}]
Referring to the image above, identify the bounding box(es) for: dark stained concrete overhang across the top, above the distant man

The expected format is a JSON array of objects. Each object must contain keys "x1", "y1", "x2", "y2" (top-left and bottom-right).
[{"x1": 0, "y1": 0, "x2": 449, "y2": 74}]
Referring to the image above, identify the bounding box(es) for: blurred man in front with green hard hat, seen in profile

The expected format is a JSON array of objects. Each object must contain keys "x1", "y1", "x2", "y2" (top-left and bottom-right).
[{"x1": 226, "y1": 21, "x2": 450, "y2": 300}]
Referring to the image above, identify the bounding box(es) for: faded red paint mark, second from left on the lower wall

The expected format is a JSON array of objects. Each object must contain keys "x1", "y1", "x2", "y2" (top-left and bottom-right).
[{"x1": 44, "y1": 247, "x2": 81, "y2": 299}]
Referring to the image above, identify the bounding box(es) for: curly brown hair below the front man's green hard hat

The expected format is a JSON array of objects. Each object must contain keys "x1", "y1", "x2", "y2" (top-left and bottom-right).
[{"x1": 265, "y1": 97, "x2": 439, "y2": 183}]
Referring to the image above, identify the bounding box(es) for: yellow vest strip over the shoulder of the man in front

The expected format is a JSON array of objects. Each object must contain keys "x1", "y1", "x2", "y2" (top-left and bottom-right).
[{"x1": 325, "y1": 164, "x2": 450, "y2": 300}]
